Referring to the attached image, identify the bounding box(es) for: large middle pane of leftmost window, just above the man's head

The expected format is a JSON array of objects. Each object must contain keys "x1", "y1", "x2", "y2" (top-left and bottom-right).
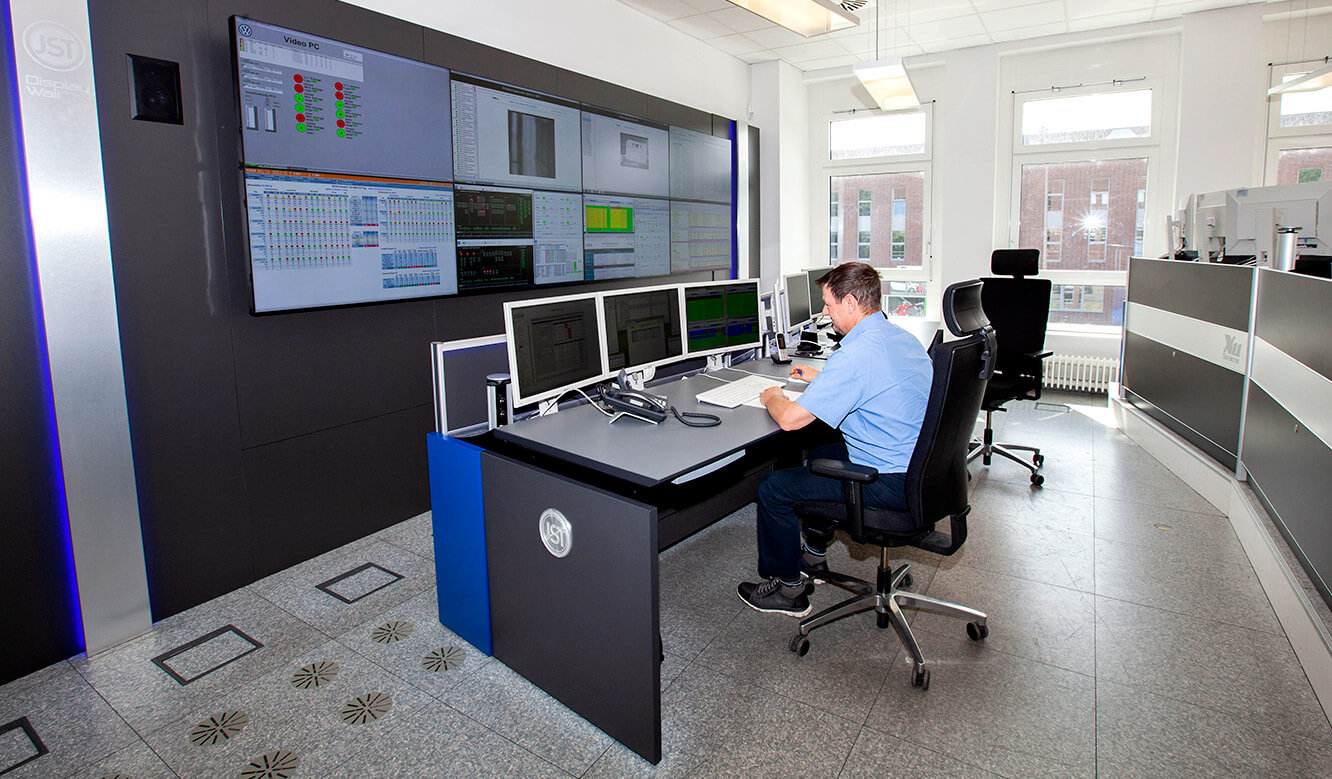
[{"x1": 829, "y1": 172, "x2": 924, "y2": 269}]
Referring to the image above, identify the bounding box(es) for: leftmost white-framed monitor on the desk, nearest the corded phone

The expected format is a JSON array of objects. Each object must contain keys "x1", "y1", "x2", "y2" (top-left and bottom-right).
[{"x1": 503, "y1": 294, "x2": 603, "y2": 405}]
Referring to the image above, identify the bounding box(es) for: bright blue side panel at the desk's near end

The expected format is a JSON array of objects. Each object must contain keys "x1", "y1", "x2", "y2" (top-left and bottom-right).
[{"x1": 426, "y1": 433, "x2": 492, "y2": 655}]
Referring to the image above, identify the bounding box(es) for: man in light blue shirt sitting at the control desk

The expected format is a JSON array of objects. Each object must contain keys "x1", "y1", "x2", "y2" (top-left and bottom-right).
[{"x1": 738, "y1": 262, "x2": 934, "y2": 617}]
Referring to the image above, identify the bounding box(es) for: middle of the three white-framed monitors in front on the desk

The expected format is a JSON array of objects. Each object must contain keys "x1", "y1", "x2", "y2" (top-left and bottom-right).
[{"x1": 601, "y1": 286, "x2": 685, "y2": 374}]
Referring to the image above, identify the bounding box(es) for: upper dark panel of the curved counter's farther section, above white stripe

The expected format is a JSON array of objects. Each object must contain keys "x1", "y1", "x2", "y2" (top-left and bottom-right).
[{"x1": 1128, "y1": 260, "x2": 1253, "y2": 327}]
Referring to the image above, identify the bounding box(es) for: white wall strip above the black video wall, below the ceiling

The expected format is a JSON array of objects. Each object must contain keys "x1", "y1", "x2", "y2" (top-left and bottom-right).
[{"x1": 345, "y1": 0, "x2": 750, "y2": 120}]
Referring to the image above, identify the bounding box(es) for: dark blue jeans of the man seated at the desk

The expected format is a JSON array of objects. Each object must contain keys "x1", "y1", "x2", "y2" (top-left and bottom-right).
[{"x1": 758, "y1": 443, "x2": 907, "y2": 582}]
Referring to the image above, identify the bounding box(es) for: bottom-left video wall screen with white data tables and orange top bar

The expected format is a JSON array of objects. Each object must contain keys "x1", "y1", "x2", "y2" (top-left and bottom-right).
[{"x1": 245, "y1": 168, "x2": 458, "y2": 313}]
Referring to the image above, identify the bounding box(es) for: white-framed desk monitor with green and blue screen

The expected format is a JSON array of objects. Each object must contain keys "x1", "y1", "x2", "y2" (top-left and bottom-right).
[{"x1": 682, "y1": 280, "x2": 762, "y2": 357}]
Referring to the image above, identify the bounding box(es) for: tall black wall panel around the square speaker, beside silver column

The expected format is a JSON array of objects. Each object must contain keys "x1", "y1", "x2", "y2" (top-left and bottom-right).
[{"x1": 88, "y1": 0, "x2": 252, "y2": 619}]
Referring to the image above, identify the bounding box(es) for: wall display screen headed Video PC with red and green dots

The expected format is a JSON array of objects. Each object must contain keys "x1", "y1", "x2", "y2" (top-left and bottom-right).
[{"x1": 232, "y1": 16, "x2": 453, "y2": 181}]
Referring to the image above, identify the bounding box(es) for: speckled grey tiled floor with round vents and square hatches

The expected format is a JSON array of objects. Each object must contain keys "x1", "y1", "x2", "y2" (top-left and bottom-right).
[{"x1": 0, "y1": 395, "x2": 1332, "y2": 778}]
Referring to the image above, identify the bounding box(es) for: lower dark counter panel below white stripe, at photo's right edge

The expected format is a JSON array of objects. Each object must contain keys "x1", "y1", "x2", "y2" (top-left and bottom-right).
[{"x1": 1244, "y1": 386, "x2": 1332, "y2": 602}]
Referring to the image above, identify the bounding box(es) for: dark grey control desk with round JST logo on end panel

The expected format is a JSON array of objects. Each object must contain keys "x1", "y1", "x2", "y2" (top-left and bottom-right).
[{"x1": 432, "y1": 360, "x2": 801, "y2": 763}]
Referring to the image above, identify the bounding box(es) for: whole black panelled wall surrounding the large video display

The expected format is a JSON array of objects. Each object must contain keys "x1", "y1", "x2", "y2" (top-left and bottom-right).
[{"x1": 85, "y1": 0, "x2": 727, "y2": 620}]
